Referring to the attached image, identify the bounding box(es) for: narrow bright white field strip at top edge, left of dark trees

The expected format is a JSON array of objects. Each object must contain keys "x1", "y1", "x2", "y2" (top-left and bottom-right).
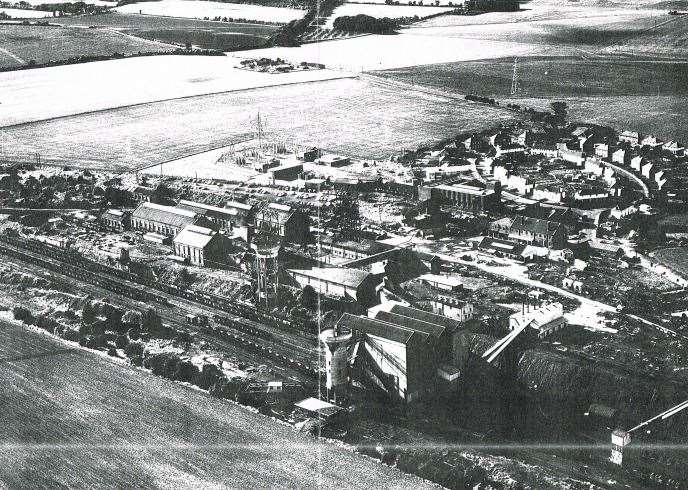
[{"x1": 115, "y1": 0, "x2": 306, "y2": 24}]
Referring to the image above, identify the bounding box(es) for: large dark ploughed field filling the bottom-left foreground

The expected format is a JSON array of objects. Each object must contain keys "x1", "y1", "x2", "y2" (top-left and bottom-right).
[{"x1": 0, "y1": 322, "x2": 432, "y2": 488}]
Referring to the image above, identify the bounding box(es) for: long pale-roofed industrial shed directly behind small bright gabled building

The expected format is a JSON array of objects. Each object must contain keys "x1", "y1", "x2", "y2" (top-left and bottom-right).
[{"x1": 131, "y1": 202, "x2": 204, "y2": 237}]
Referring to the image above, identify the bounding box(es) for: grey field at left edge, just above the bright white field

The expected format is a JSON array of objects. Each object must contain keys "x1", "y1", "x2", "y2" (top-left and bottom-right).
[{"x1": 0, "y1": 24, "x2": 173, "y2": 68}]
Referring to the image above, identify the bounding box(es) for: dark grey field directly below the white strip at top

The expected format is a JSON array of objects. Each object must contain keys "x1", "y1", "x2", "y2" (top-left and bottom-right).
[{"x1": 58, "y1": 12, "x2": 277, "y2": 51}]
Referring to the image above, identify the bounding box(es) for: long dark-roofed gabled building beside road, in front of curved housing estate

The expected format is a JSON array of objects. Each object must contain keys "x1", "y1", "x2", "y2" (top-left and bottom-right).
[{"x1": 489, "y1": 215, "x2": 566, "y2": 250}]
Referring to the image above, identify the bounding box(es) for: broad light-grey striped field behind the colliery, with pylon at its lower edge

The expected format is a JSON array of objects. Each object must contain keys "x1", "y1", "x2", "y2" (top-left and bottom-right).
[{"x1": 3, "y1": 79, "x2": 517, "y2": 169}]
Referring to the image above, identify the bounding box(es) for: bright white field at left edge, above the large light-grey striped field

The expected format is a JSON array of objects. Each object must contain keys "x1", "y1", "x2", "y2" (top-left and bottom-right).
[{"x1": 0, "y1": 55, "x2": 346, "y2": 126}]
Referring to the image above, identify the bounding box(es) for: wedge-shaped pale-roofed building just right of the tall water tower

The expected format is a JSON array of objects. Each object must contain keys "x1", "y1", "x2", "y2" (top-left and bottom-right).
[{"x1": 287, "y1": 267, "x2": 380, "y2": 308}]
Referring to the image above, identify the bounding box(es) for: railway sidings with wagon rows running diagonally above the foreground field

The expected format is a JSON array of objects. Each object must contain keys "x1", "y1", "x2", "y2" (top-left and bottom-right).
[{"x1": 0, "y1": 242, "x2": 318, "y2": 381}]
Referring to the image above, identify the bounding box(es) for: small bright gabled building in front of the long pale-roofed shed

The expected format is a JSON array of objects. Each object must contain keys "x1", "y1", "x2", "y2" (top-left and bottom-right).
[{"x1": 172, "y1": 225, "x2": 230, "y2": 267}]
